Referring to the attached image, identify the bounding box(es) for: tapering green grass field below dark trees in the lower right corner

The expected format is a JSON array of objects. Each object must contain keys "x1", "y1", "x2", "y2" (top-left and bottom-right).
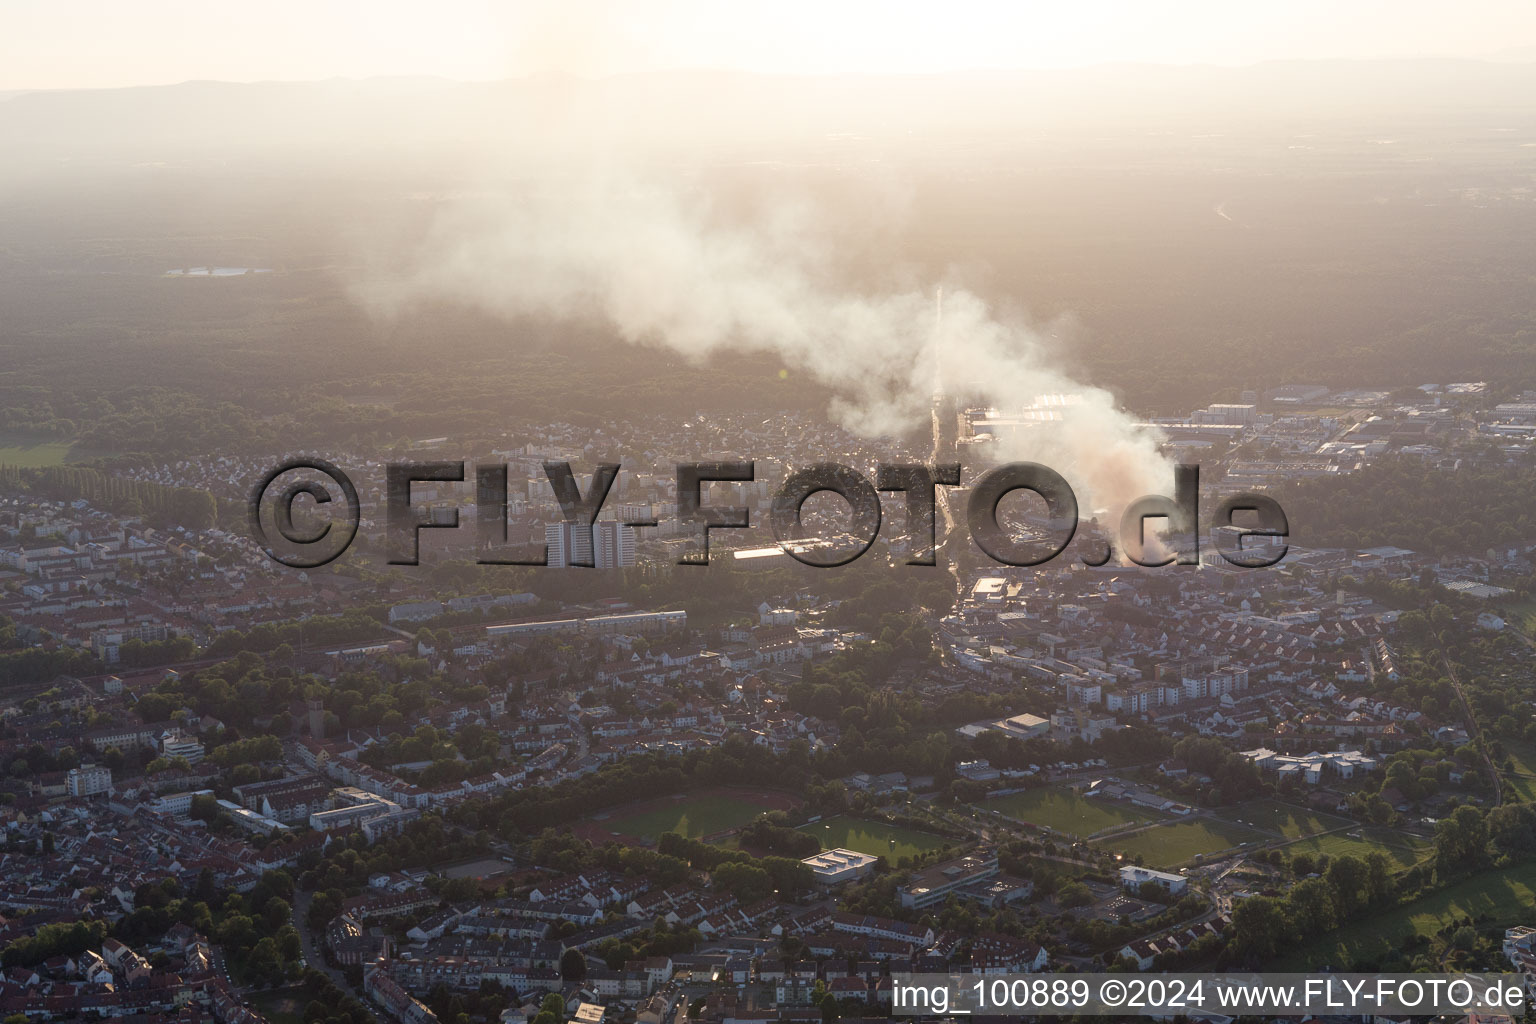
[{"x1": 1273, "y1": 864, "x2": 1536, "y2": 970}]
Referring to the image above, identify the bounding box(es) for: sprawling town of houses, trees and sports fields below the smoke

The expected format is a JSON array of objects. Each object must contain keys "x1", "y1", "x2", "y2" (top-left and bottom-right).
[{"x1": 0, "y1": 382, "x2": 1536, "y2": 1024}]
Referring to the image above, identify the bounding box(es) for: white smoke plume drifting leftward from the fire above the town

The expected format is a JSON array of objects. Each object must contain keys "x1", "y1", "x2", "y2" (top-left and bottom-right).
[{"x1": 364, "y1": 167, "x2": 1172, "y2": 522}]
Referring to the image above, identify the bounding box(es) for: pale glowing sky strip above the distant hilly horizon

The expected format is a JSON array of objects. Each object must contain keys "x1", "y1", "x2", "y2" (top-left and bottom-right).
[{"x1": 9, "y1": 0, "x2": 1536, "y2": 89}]
